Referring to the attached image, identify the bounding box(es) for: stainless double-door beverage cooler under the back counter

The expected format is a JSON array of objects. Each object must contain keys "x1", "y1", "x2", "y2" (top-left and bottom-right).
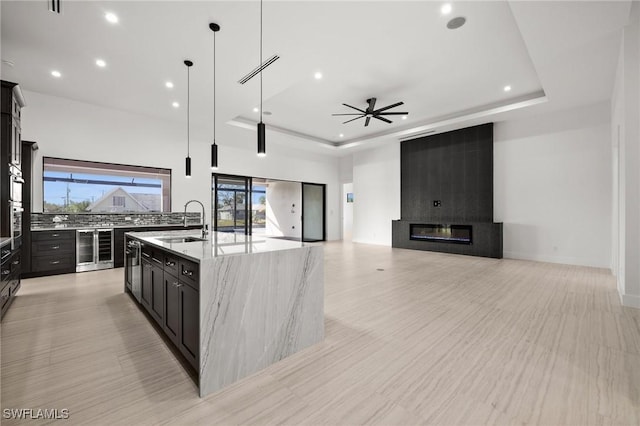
[{"x1": 76, "y1": 229, "x2": 113, "y2": 272}]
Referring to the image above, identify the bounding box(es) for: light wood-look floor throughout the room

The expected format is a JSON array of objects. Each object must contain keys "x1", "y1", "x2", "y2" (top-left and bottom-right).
[{"x1": 1, "y1": 242, "x2": 640, "y2": 425}]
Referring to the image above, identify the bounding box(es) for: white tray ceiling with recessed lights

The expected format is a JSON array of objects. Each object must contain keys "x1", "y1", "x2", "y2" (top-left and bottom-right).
[{"x1": 1, "y1": 0, "x2": 631, "y2": 151}]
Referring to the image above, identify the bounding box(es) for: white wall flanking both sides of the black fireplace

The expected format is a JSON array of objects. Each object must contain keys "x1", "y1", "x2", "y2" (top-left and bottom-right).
[{"x1": 353, "y1": 103, "x2": 612, "y2": 268}]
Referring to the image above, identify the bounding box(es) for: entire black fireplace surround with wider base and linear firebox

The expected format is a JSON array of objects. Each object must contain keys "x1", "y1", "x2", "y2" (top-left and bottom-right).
[{"x1": 392, "y1": 123, "x2": 502, "y2": 258}]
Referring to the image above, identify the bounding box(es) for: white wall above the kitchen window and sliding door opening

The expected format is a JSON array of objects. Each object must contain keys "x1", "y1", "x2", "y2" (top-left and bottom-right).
[{"x1": 22, "y1": 91, "x2": 342, "y2": 240}]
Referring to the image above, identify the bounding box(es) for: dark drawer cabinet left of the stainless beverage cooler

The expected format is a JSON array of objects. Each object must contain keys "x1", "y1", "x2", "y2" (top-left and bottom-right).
[{"x1": 29, "y1": 230, "x2": 76, "y2": 276}]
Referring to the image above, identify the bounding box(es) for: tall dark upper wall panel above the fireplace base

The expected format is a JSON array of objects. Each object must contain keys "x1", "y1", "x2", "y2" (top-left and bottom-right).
[{"x1": 400, "y1": 123, "x2": 493, "y2": 223}]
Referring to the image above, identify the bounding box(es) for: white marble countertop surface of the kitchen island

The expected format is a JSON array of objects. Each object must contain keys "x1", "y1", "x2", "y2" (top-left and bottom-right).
[{"x1": 126, "y1": 230, "x2": 318, "y2": 262}]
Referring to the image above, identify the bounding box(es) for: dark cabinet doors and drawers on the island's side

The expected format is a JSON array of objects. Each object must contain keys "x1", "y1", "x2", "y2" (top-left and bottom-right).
[{"x1": 131, "y1": 243, "x2": 200, "y2": 370}]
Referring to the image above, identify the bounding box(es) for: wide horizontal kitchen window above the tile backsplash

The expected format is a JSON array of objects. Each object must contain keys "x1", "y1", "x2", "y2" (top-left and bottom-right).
[{"x1": 42, "y1": 157, "x2": 171, "y2": 213}]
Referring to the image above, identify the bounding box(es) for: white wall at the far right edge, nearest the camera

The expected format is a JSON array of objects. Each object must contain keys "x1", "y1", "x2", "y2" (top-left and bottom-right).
[{"x1": 611, "y1": 3, "x2": 640, "y2": 308}]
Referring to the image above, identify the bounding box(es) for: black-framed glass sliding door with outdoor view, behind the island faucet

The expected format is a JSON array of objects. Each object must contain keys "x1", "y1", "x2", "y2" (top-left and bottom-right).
[{"x1": 212, "y1": 174, "x2": 251, "y2": 235}]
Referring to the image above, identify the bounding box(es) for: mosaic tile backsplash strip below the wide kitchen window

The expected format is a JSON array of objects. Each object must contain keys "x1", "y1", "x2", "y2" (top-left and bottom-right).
[{"x1": 31, "y1": 212, "x2": 202, "y2": 230}]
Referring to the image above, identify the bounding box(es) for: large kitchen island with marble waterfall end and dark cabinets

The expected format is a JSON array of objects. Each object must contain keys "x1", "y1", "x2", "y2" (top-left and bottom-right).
[{"x1": 125, "y1": 231, "x2": 324, "y2": 396}]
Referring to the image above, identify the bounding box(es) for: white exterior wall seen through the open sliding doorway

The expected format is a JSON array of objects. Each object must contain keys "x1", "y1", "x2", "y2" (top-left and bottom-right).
[{"x1": 265, "y1": 181, "x2": 302, "y2": 238}]
